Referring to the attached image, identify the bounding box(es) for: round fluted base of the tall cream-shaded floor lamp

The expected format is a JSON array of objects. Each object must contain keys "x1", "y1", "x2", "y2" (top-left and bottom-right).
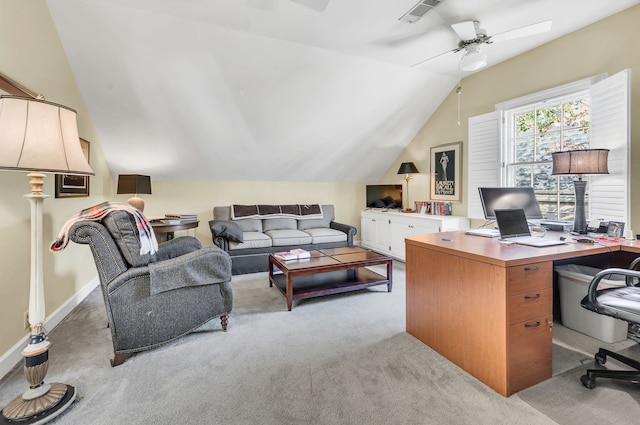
[{"x1": 0, "y1": 382, "x2": 76, "y2": 425}]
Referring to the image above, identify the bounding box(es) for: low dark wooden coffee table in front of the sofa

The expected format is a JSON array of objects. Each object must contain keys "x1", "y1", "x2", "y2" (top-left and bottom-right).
[{"x1": 269, "y1": 246, "x2": 392, "y2": 311}]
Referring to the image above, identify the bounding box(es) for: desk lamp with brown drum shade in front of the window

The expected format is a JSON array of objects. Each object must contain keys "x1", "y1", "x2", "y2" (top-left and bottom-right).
[{"x1": 551, "y1": 149, "x2": 609, "y2": 234}]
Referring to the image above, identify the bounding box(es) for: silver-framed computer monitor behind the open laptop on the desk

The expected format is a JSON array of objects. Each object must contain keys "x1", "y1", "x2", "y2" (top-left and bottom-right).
[{"x1": 478, "y1": 187, "x2": 543, "y2": 220}]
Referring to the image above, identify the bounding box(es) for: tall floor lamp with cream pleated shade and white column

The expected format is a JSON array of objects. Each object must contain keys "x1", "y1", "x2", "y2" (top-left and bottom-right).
[{"x1": 0, "y1": 96, "x2": 93, "y2": 424}]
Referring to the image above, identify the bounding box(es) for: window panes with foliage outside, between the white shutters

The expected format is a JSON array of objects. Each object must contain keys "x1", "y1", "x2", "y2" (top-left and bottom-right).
[{"x1": 505, "y1": 91, "x2": 590, "y2": 220}]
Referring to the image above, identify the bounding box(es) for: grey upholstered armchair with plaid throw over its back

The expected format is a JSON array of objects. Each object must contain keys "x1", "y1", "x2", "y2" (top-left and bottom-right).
[{"x1": 69, "y1": 211, "x2": 233, "y2": 366}]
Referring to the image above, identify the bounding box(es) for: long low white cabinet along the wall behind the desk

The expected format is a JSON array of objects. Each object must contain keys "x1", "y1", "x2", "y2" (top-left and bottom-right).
[{"x1": 360, "y1": 210, "x2": 469, "y2": 261}]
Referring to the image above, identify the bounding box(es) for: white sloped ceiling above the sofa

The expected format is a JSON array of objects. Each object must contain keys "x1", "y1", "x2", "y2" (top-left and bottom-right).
[{"x1": 47, "y1": 0, "x2": 640, "y2": 181}]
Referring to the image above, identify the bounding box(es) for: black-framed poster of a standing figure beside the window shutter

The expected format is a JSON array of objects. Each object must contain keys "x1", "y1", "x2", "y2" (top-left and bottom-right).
[{"x1": 430, "y1": 142, "x2": 462, "y2": 202}]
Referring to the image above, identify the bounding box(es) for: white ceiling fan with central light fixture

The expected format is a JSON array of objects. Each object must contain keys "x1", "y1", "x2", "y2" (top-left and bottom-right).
[{"x1": 411, "y1": 20, "x2": 551, "y2": 71}]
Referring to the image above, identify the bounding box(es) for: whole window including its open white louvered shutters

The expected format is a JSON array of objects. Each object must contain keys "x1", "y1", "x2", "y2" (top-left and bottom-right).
[{"x1": 467, "y1": 69, "x2": 631, "y2": 223}]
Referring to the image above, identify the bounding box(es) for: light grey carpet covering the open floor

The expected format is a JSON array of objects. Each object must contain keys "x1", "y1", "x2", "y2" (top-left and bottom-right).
[{"x1": 0, "y1": 263, "x2": 632, "y2": 425}]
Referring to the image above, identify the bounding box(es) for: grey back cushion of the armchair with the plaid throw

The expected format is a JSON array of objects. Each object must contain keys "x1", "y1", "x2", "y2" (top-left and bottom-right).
[{"x1": 102, "y1": 210, "x2": 156, "y2": 267}]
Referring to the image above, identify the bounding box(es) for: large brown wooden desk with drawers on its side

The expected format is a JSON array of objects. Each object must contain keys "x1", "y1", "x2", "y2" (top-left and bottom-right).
[{"x1": 405, "y1": 231, "x2": 640, "y2": 397}]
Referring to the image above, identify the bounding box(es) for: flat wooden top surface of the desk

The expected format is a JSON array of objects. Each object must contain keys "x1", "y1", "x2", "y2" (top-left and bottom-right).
[{"x1": 405, "y1": 231, "x2": 640, "y2": 267}]
